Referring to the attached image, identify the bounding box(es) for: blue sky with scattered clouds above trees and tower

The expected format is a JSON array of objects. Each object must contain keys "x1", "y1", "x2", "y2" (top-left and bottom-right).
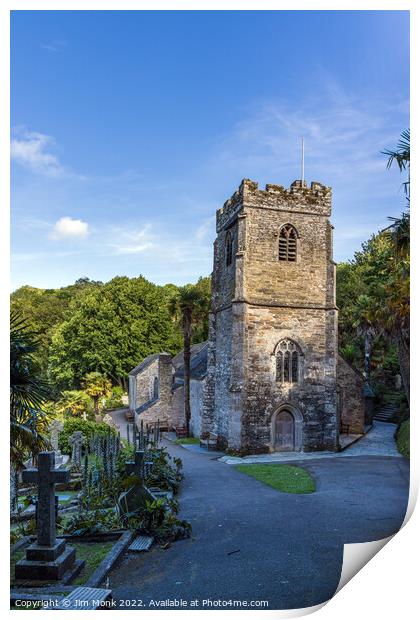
[{"x1": 11, "y1": 11, "x2": 409, "y2": 288}]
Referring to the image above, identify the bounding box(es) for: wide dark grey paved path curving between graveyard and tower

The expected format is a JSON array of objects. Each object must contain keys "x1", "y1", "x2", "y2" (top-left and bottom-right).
[{"x1": 109, "y1": 436, "x2": 409, "y2": 611}]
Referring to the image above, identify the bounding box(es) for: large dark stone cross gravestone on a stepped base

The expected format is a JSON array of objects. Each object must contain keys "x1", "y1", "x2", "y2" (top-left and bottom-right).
[{"x1": 15, "y1": 451, "x2": 83, "y2": 581}]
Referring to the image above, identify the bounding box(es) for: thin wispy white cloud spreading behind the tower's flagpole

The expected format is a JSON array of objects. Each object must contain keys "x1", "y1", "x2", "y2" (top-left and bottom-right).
[{"x1": 216, "y1": 83, "x2": 408, "y2": 191}]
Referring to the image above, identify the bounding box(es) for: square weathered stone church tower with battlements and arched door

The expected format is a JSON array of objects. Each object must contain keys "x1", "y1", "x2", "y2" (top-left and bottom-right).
[{"x1": 202, "y1": 180, "x2": 339, "y2": 454}]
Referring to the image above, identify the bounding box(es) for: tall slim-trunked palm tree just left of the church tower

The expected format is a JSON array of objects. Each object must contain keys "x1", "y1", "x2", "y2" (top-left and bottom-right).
[{"x1": 170, "y1": 284, "x2": 209, "y2": 436}]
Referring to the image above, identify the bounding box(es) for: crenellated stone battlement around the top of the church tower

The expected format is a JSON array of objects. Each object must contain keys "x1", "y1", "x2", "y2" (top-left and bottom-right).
[{"x1": 216, "y1": 179, "x2": 331, "y2": 231}]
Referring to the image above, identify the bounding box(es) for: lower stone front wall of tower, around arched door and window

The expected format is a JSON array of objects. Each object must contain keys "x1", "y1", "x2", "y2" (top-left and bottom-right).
[{"x1": 243, "y1": 306, "x2": 338, "y2": 452}]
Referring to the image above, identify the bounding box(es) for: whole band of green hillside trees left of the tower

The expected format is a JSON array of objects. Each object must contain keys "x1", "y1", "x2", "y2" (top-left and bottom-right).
[{"x1": 11, "y1": 276, "x2": 210, "y2": 392}]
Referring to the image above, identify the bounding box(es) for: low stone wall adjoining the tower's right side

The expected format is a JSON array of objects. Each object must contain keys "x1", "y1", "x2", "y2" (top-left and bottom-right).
[{"x1": 337, "y1": 355, "x2": 365, "y2": 433}]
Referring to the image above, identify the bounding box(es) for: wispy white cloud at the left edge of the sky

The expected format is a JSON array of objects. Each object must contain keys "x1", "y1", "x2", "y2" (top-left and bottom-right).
[{"x1": 10, "y1": 132, "x2": 64, "y2": 177}]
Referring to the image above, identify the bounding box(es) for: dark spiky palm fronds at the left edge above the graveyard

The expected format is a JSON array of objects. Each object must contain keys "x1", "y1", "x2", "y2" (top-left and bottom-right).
[{"x1": 10, "y1": 312, "x2": 49, "y2": 470}]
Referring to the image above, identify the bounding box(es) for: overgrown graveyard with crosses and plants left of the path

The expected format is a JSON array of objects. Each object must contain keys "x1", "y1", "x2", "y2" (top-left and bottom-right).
[{"x1": 11, "y1": 415, "x2": 190, "y2": 608}]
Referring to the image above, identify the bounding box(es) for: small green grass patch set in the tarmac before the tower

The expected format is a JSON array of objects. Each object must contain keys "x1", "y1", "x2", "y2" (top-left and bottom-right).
[{"x1": 234, "y1": 463, "x2": 315, "y2": 493}]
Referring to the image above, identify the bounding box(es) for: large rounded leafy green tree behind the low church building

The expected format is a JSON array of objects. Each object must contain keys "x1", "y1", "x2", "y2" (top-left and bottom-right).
[{"x1": 49, "y1": 276, "x2": 182, "y2": 390}]
